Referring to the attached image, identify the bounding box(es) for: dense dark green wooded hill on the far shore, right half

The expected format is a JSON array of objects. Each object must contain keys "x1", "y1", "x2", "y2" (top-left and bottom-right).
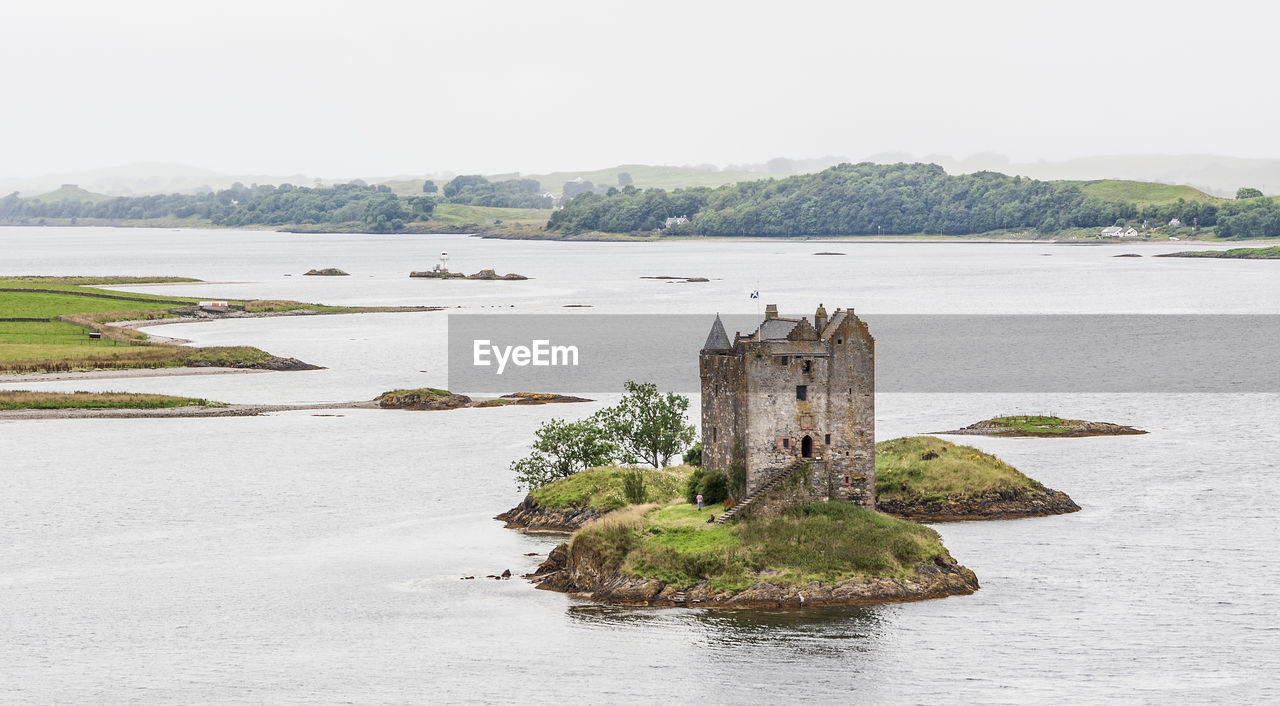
[{"x1": 548, "y1": 162, "x2": 1275, "y2": 237}]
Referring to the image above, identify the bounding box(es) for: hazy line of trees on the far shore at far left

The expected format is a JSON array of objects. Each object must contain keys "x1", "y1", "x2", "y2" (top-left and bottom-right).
[{"x1": 0, "y1": 183, "x2": 435, "y2": 233}]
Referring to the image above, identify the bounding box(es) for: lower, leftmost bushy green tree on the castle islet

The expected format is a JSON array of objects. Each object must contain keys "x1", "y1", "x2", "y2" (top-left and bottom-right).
[{"x1": 511, "y1": 420, "x2": 617, "y2": 490}]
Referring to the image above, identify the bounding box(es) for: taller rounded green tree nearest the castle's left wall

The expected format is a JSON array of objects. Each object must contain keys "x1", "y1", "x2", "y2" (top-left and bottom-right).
[{"x1": 596, "y1": 380, "x2": 694, "y2": 468}]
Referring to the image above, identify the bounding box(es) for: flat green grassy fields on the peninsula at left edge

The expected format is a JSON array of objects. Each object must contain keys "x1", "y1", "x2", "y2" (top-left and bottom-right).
[{"x1": 0, "y1": 276, "x2": 438, "y2": 373}]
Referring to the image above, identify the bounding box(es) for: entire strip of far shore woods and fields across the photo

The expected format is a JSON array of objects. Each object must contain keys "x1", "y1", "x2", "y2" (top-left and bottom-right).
[{"x1": 10, "y1": 162, "x2": 1280, "y2": 242}]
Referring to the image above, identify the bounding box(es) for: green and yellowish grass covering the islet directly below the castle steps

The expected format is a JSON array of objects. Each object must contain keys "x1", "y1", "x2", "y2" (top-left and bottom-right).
[{"x1": 571, "y1": 501, "x2": 948, "y2": 591}]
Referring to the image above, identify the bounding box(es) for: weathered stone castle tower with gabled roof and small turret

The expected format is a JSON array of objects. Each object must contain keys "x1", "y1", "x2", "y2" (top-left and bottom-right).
[{"x1": 699, "y1": 304, "x2": 876, "y2": 509}]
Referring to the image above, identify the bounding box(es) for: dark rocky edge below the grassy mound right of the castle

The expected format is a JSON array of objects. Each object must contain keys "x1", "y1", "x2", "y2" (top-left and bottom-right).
[{"x1": 876, "y1": 487, "x2": 1080, "y2": 523}]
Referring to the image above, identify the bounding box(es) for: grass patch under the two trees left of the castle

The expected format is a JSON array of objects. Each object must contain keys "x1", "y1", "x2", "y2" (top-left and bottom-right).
[{"x1": 530, "y1": 466, "x2": 694, "y2": 513}]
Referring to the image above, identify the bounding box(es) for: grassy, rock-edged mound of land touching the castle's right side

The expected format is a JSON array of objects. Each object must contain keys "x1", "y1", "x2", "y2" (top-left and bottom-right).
[{"x1": 876, "y1": 436, "x2": 1080, "y2": 522}]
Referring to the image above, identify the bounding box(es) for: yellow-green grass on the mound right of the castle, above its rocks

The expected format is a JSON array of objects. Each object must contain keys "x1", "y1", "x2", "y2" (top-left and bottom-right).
[{"x1": 876, "y1": 436, "x2": 1041, "y2": 503}]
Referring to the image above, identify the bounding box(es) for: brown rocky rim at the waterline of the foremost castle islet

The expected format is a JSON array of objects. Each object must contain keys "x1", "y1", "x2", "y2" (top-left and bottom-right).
[{"x1": 526, "y1": 545, "x2": 979, "y2": 609}]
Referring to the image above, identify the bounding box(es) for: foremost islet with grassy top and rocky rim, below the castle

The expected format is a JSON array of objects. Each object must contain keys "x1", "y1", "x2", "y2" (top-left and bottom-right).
[{"x1": 530, "y1": 500, "x2": 978, "y2": 608}]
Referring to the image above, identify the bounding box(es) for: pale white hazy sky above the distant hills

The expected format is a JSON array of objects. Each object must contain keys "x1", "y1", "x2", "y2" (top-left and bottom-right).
[{"x1": 0, "y1": 0, "x2": 1280, "y2": 177}]
